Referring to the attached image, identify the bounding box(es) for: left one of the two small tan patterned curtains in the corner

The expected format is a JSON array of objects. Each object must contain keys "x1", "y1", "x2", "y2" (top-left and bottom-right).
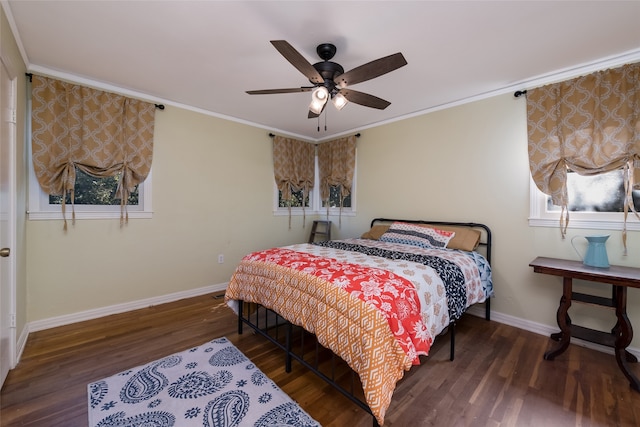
[{"x1": 273, "y1": 135, "x2": 315, "y2": 228}]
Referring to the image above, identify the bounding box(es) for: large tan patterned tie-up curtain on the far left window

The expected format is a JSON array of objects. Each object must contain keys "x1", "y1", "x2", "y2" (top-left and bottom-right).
[{"x1": 31, "y1": 75, "x2": 155, "y2": 229}]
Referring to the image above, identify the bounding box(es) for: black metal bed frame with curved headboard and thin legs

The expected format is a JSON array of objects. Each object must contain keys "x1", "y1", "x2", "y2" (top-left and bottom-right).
[{"x1": 238, "y1": 218, "x2": 492, "y2": 427}]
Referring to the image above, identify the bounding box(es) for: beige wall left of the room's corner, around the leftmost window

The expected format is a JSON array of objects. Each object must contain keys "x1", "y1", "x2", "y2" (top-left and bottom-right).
[{"x1": 27, "y1": 106, "x2": 308, "y2": 321}]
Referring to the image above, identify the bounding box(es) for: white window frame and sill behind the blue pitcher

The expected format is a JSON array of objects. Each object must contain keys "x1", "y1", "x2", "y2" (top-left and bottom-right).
[{"x1": 529, "y1": 175, "x2": 640, "y2": 231}]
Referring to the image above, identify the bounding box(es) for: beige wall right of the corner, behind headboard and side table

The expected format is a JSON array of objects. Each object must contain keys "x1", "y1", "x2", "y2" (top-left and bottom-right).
[{"x1": 341, "y1": 94, "x2": 640, "y2": 348}]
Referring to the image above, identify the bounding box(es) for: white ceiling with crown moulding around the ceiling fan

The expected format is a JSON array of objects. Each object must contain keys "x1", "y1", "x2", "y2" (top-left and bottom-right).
[{"x1": 2, "y1": 0, "x2": 640, "y2": 141}]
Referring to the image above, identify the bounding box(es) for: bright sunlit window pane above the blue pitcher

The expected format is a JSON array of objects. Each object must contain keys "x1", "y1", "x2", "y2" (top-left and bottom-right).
[{"x1": 547, "y1": 169, "x2": 640, "y2": 212}]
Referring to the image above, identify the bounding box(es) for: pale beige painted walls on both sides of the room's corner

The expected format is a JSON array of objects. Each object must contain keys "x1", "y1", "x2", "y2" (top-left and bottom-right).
[{"x1": 21, "y1": 78, "x2": 640, "y2": 347}]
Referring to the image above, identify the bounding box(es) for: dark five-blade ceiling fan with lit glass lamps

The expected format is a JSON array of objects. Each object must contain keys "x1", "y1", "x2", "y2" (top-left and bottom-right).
[{"x1": 247, "y1": 40, "x2": 407, "y2": 119}]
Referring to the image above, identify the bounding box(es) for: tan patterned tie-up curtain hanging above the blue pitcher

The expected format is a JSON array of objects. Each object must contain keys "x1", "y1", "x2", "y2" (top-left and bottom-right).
[{"x1": 527, "y1": 63, "x2": 640, "y2": 247}]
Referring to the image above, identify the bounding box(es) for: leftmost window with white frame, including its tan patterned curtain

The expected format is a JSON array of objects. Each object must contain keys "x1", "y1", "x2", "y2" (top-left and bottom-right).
[{"x1": 26, "y1": 75, "x2": 156, "y2": 222}]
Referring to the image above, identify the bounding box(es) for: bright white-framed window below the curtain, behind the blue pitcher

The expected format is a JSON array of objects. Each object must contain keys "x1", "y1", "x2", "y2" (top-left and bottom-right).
[{"x1": 529, "y1": 169, "x2": 640, "y2": 230}]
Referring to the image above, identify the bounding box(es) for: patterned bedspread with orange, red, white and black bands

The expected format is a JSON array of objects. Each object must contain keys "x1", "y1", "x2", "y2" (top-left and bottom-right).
[{"x1": 225, "y1": 239, "x2": 493, "y2": 425}]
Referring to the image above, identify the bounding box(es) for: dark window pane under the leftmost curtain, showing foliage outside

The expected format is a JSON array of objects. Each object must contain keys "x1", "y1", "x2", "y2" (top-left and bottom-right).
[{"x1": 49, "y1": 168, "x2": 138, "y2": 206}]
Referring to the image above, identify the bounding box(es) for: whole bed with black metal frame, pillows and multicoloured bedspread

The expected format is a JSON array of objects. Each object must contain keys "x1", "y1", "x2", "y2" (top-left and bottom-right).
[{"x1": 225, "y1": 218, "x2": 493, "y2": 425}]
